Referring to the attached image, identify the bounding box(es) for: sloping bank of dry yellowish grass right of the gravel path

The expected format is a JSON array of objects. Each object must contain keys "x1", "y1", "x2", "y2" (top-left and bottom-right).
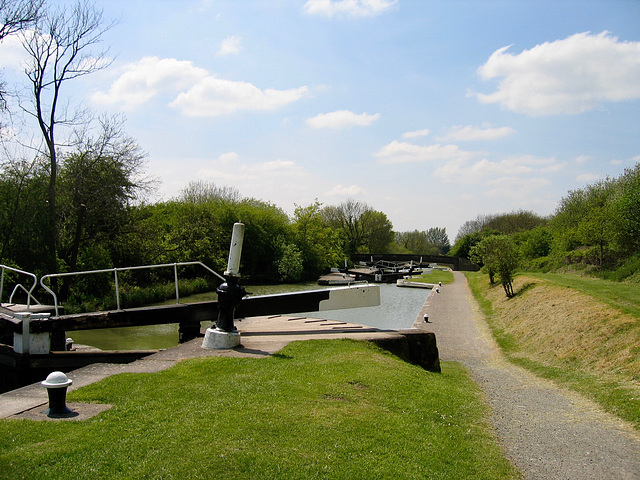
[{"x1": 467, "y1": 273, "x2": 640, "y2": 429}]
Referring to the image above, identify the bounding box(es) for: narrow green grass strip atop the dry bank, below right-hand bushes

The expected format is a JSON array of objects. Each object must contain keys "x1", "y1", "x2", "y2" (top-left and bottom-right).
[{"x1": 527, "y1": 272, "x2": 640, "y2": 318}]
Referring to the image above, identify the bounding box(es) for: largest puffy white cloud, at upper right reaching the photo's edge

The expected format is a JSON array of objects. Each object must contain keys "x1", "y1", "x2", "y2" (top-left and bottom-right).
[{"x1": 476, "y1": 32, "x2": 640, "y2": 116}]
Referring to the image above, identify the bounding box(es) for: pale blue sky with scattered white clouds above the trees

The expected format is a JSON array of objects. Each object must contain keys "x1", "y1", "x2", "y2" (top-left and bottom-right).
[{"x1": 0, "y1": 0, "x2": 640, "y2": 242}]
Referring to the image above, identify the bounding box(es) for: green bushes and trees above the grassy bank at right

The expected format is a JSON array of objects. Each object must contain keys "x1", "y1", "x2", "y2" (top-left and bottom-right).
[{"x1": 450, "y1": 163, "x2": 640, "y2": 296}]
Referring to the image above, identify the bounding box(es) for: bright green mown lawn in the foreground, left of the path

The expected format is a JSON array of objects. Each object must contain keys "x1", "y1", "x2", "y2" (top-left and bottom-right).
[{"x1": 0, "y1": 340, "x2": 519, "y2": 479}]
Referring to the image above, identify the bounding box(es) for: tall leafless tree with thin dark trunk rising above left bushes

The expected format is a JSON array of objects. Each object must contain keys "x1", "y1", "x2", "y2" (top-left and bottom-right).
[{"x1": 22, "y1": 1, "x2": 113, "y2": 272}]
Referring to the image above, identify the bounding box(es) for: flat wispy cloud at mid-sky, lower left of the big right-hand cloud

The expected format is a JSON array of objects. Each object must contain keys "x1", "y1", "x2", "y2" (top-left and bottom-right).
[{"x1": 374, "y1": 140, "x2": 475, "y2": 164}]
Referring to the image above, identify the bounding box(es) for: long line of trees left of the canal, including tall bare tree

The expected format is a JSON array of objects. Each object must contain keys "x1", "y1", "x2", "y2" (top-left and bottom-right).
[{"x1": 0, "y1": 0, "x2": 449, "y2": 291}]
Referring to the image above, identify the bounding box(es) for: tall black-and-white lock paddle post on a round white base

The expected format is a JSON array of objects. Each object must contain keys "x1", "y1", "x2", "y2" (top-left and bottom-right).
[{"x1": 202, "y1": 223, "x2": 246, "y2": 350}]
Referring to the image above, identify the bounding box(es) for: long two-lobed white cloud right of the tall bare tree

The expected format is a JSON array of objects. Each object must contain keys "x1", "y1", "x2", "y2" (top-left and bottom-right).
[{"x1": 92, "y1": 57, "x2": 308, "y2": 117}]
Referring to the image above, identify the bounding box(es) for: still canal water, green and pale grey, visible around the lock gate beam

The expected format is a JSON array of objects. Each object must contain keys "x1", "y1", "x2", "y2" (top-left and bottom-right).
[{"x1": 68, "y1": 283, "x2": 431, "y2": 350}]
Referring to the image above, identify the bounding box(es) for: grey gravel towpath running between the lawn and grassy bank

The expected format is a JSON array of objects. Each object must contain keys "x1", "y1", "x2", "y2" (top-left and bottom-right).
[{"x1": 416, "y1": 272, "x2": 640, "y2": 480}]
